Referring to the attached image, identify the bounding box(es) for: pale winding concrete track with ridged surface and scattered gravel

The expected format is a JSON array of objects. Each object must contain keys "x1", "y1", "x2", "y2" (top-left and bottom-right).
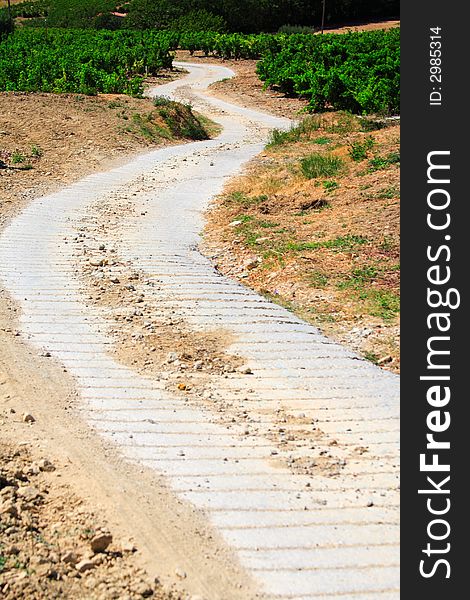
[{"x1": 0, "y1": 64, "x2": 399, "y2": 600}]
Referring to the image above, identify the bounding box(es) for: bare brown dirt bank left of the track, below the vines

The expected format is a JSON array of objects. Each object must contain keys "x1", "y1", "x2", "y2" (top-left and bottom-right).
[{"x1": 0, "y1": 72, "x2": 193, "y2": 225}]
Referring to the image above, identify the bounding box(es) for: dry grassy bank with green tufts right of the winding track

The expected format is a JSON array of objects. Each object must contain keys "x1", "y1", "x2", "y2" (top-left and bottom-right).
[{"x1": 205, "y1": 113, "x2": 400, "y2": 371}]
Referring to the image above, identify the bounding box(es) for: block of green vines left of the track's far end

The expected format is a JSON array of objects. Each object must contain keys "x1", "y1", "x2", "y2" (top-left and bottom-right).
[{"x1": 0, "y1": 29, "x2": 172, "y2": 96}]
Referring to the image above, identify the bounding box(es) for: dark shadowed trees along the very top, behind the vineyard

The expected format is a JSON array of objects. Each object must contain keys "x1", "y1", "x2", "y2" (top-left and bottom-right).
[{"x1": 4, "y1": 0, "x2": 400, "y2": 34}]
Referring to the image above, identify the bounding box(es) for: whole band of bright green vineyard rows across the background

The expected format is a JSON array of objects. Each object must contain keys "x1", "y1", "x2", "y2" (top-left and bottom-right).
[{"x1": 0, "y1": 26, "x2": 400, "y2": 114}]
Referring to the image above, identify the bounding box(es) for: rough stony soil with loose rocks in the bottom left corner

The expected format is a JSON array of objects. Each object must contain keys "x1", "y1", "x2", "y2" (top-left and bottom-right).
[{"x1": 0, "y1": 440, "x2": 182, "y2": 600}]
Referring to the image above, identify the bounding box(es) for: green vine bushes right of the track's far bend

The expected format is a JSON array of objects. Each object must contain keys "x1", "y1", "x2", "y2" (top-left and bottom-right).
[{"x1": 258, "y1": 29, "x2": 400, "y2": 114}]
